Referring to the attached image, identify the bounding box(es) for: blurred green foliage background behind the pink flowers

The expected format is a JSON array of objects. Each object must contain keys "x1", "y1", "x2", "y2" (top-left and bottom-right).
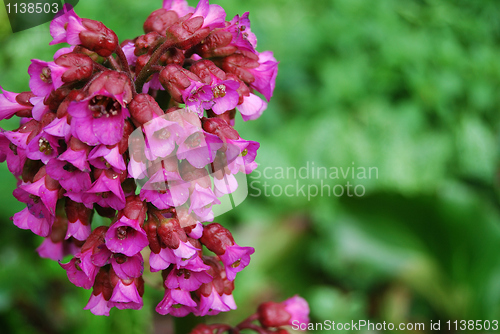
[{"x1": 0, "y1": 0, "x2": 500, "y2": 334}]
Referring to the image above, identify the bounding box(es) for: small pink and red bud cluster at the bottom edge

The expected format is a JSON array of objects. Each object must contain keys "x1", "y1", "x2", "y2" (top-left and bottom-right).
[{"x1": 190, "y1": 296, "x2": 309, "y2": 334}]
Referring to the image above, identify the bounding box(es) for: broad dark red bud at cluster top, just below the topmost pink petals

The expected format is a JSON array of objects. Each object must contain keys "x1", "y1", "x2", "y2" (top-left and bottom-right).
[{"x1": 167, "y1": 14, "x2": 210, "y2": 50}]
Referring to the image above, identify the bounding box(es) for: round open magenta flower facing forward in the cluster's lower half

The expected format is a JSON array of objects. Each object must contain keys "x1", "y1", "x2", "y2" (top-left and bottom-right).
[{"x1": 105, "y1": 216, "x2": 148, "y2": 256}]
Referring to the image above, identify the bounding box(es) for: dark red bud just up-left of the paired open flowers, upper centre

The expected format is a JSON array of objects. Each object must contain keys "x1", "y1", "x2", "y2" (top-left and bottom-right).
[{"x1": 160, "y1": 64, "x2": 200, "y2": 103}]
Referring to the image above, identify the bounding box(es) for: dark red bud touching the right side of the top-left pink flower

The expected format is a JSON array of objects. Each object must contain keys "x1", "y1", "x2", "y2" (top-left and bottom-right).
[{"x1": 78, "y1": 19, "x2": 118, "y2": 57}]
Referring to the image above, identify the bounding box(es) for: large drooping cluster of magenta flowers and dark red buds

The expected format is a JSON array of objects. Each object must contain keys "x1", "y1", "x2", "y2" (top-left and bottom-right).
[{"x1": 0, "y1": 0, "x2": 278, "y2": 316}]
